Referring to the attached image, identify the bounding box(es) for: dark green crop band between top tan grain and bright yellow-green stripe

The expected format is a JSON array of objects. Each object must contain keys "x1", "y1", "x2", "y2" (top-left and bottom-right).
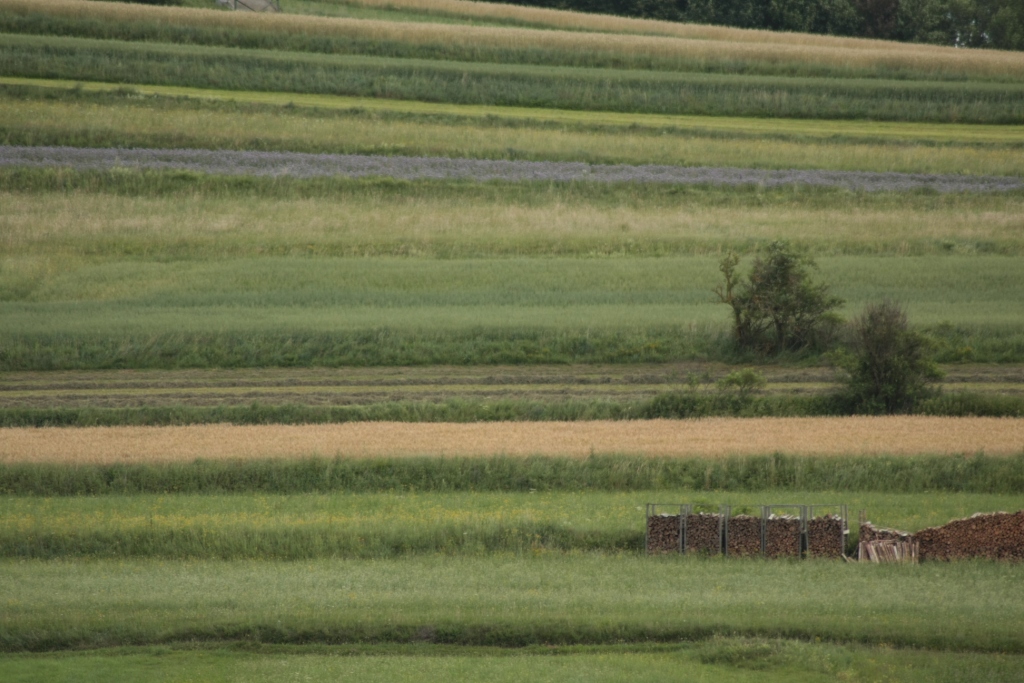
[{"x1": 0, "y1": 35, "x2": 1024, "y2": 124}]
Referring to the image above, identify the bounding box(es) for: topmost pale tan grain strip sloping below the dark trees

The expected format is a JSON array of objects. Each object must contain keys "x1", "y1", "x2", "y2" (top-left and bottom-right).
[{"x1": 8, "y1": 0, "x2": 1024, "y2": 77}]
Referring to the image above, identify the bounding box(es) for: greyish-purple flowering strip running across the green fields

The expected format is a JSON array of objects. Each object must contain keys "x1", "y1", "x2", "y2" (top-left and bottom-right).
[{"x1": 0, "y1": 145, "x2": 1024, "y2": 193}]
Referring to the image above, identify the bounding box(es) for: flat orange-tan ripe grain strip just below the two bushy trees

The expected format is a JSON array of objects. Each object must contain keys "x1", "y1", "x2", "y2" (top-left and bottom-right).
[{"x1": 0, "y1": 417, "x2": 1024, "y2": 464}]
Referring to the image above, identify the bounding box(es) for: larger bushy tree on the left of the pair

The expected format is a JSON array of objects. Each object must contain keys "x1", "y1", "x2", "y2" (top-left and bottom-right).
[{"x1": 715, "y1": 242, "x2": 843, "y2": 355}]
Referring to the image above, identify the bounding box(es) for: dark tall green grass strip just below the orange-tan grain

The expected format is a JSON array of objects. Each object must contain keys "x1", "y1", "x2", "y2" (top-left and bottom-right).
[{"x1": 0, "y1": 452, "x2": 1024, "y2": 497}]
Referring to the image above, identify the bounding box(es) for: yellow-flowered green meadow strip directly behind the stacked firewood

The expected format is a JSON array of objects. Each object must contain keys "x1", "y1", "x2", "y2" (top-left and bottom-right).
[{"x1": 0, "y1": 489, "x2": 1020, "y2": 560}]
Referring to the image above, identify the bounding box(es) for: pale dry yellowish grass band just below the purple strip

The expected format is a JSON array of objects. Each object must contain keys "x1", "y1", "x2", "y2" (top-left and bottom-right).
[{"x1": 8, "y1": 191, "x2": 1024, "y2": 257}]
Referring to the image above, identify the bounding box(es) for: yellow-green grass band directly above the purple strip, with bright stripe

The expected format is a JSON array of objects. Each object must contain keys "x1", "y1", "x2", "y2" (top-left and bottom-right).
[{"x1": 8, "y1": 80, "x2": 1024, "y2": 175}]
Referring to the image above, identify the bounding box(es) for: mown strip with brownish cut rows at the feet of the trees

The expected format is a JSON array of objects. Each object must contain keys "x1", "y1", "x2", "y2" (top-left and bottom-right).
[{"x1": 0, "y1": 362, "x2": 1024, "y2": 410}]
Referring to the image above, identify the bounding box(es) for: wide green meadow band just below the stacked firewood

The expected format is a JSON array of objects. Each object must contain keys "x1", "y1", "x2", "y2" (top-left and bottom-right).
[{"x1": 0, "y1": 553, "x2": 1024, "y2": 653}]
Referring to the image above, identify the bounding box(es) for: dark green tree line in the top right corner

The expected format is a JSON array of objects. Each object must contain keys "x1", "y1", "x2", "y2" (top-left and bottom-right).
[{"x1": 505, "y1": 0, "x2": 1024, "y2": 50}]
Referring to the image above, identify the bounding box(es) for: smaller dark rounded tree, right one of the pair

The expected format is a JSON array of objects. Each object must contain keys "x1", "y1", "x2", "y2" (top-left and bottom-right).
[{"x1": 841, "y1": 301, "x2": 942, "y2": 414}]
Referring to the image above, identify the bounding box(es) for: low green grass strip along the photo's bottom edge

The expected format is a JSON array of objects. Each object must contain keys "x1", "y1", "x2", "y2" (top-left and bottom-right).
[{"x1": 0, "y1": 637, "x2": 1024, "y2": 683}]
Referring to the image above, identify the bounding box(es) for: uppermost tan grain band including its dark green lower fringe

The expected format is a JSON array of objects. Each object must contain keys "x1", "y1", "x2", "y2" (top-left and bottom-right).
[{"x1": 0, "y1": 0, "x2": 1024, "y2": 80}]
